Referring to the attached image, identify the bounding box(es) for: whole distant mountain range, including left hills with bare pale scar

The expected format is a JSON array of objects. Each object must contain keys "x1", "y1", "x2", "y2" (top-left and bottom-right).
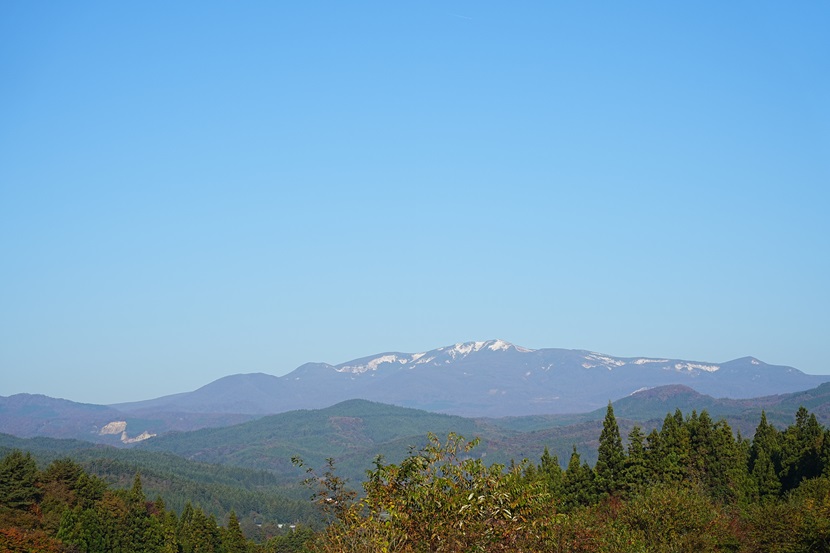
[{"x1": 0, "y1": 340, "x2": 830, "y2": 445}]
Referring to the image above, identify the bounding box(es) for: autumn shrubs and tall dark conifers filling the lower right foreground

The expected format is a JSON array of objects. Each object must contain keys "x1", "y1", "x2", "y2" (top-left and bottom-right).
[{"x1": 307, "y1": 405, "x2": 830, "y2": 553}]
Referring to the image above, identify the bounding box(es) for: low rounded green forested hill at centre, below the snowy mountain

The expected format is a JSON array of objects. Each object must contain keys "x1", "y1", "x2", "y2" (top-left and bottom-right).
[{"x1": 137, "y1": 400, "x2": 515, "y2": 482}]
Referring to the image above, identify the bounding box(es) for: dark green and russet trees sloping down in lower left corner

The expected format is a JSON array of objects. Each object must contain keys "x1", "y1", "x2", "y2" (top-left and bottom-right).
[{"x1": 0, "y1": 450, "x2": 310, "y2": 553}]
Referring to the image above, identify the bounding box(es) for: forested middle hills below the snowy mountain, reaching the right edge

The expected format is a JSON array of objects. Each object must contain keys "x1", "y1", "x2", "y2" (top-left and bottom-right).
[{"x1": 132, "y1": 384, "x2": 830, "y2": 481}]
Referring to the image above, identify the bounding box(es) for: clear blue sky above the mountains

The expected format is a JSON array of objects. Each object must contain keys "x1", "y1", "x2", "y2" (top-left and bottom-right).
[{"x1": 0, "y1": 0, "x2": 830, "y2": 403}]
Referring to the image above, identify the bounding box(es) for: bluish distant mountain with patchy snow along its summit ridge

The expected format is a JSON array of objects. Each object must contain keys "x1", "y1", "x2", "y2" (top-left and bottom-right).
[{"x1": 115, "y1": 340, "x2": 830, "y2": 416}]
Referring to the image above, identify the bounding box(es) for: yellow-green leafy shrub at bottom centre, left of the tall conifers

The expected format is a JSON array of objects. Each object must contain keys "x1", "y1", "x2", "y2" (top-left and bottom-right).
[{"x1": 296, "y1": 434, "x2": 555, "y2": 552}]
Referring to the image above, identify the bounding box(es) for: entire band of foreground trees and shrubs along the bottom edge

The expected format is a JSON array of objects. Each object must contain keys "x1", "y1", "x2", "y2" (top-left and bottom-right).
[{"x1": 0, "y1": 404, "x2": 830, "y2": 553}]
